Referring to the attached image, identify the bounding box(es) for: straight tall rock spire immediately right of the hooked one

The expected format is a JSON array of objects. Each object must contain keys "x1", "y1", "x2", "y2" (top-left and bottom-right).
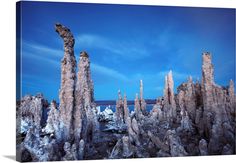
[{"x1": 73, "y1": 51, "x2": 98, "y2": 144}]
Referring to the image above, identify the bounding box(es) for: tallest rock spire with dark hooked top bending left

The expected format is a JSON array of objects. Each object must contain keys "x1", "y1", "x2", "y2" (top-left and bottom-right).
[{"x1": 55, "y1": 24, "x2": 76, "y2": 140}]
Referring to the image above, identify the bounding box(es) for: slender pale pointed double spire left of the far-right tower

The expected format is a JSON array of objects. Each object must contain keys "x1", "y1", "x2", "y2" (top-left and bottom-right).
[{"x1": 164, "y1": 71, "x2": 176, "y2": 121}]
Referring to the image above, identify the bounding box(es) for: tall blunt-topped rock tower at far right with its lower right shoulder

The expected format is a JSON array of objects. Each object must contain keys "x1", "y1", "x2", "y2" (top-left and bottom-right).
[{"x1": 199, "y1": 53, "x2": 235, "y2": 154}]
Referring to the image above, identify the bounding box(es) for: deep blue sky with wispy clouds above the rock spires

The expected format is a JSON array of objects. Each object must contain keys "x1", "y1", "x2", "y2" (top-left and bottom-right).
[{"x1": 18, "y1": 2, "x2": 235, "y2": 101}]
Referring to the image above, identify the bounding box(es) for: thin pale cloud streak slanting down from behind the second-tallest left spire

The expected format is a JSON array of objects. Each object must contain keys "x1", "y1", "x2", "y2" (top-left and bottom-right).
[{"x1": 91, "y1": 63, "x2": 129, "y2": 81}]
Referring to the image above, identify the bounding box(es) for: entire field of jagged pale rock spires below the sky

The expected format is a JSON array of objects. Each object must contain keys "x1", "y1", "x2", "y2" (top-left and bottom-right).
[{"x1": 16, "y1": 24, "x2": 236, "y2": 161}]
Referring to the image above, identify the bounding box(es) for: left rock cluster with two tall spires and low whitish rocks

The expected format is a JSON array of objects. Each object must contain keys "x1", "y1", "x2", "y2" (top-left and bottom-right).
[{"x1": 17, "y1": 24, "x2": 98, "y2": 161}]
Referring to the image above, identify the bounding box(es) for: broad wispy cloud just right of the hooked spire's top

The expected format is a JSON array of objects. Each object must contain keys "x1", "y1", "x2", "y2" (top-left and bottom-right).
[{"x1": 77, "y1": 34, "x2": 150, "y2": 60}]
